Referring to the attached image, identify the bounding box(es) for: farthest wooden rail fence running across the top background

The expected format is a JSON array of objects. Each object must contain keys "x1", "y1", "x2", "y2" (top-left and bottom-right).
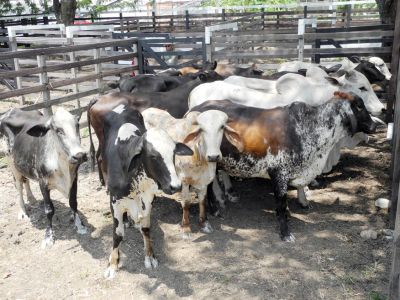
[{"x1": 0, "y1": 5, "x2": 380, "y2": 32}]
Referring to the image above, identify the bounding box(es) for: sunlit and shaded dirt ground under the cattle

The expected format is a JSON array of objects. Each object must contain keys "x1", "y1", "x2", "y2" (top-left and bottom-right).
[{"x1": 0, "y1": 125, "x2": 392, "y2": 300}]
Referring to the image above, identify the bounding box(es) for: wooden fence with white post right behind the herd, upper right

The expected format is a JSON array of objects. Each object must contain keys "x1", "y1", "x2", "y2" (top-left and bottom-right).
[{"x1": 208, "y1": 25, "x2": 393, "y2": 62}]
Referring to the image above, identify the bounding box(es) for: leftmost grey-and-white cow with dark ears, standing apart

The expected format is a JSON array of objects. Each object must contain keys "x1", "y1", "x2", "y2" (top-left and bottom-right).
[{"x1": 0, "y1": 108, "x2": 87, "y2": 247}]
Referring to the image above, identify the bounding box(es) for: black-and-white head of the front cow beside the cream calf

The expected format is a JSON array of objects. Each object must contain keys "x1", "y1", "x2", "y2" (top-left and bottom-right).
[{"x1": 141, "y1": 128, "x2": 193, "y2": 195}]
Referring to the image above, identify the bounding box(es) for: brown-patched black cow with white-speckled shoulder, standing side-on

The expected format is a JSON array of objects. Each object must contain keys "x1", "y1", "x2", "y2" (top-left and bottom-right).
[{"x1": 192, "y1": 92, "x2": 376, "y2": 242}]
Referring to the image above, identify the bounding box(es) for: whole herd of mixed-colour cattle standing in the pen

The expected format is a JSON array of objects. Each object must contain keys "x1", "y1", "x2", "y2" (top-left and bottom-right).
[{"x1": 0, "y1": 57, "x2": 391, "y2": 278}]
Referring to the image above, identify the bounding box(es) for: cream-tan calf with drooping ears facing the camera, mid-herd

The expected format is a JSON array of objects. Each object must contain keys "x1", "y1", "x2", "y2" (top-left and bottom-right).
[{"x1": 142, "y1": 108, "x2": 236, "y2": 237}]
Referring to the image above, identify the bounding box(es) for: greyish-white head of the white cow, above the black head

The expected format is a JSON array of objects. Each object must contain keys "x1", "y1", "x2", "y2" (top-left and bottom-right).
[{"x1": 326, "y1": 70, "x2": 385, "y2": 116}]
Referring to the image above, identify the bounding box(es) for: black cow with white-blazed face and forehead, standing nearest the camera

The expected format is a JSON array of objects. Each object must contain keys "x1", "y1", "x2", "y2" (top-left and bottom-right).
[{"x1": 103, "y1": 105, "x2": 193, "y2": 279}]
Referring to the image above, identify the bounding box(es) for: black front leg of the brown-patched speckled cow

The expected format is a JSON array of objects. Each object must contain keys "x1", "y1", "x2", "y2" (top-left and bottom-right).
[{"x1": 268, "y1": 171, "x2": 295, "y2": 242}]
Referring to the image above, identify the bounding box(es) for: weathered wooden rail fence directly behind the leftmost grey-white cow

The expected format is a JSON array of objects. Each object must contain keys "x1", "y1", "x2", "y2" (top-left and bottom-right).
[{"x1": 0, "y1": 39, "x2": 138, "y2": 119}]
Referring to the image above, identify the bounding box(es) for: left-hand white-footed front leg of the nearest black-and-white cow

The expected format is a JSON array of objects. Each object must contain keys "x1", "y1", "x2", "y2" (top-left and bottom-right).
[{"x1": 104, "y1": 196, "x2": 125, "y2": 279}]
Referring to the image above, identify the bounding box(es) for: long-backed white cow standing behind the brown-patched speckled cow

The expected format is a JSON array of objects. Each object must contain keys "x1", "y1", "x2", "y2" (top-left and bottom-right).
[{"x1": 189, "y1": 71, "x2": 384, "y2": 115}]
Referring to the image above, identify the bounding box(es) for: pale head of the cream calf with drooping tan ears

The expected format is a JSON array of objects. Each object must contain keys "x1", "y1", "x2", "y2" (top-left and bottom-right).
[{"x1": 183, "y1": 110, "x2": 243, "y2": 162}]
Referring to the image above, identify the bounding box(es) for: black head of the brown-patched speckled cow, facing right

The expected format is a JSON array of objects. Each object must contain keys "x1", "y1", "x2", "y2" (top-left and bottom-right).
[{"x1": 334, "y1": 92, "x2": 376, "y2": 134}]
